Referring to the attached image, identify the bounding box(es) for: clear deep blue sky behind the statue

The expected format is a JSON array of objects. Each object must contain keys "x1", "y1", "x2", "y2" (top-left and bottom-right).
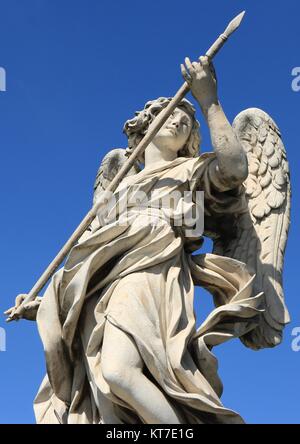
[{"x1": 0, "y1": 0, "x2": 300, "y2": 423}]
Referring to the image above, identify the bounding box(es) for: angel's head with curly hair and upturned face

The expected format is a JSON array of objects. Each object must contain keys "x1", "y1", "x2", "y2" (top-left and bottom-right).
[{"x1": 124, "y1": 97, "x2": 201, "y2": 163}]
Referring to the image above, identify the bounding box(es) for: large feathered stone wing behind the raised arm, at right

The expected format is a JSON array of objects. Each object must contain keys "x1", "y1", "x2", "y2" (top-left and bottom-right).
[{"x1": 214, "y1": 108, "x2": 291, "y2": 349}]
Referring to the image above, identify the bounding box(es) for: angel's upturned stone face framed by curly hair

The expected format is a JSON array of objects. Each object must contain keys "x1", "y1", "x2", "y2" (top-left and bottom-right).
[{"x1": 153, "y1": 108, "x2": 193, "y2": 153}]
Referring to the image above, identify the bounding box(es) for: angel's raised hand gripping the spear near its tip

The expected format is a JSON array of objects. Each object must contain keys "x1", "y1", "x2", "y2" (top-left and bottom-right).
[{"x1": 181, "y1": 56, "x2": 218, "y2": 110}]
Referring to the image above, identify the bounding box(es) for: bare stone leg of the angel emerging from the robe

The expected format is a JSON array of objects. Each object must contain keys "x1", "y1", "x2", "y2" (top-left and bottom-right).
[{"x1": 101, "y1": 322, "x2": 181, "y2": 424}]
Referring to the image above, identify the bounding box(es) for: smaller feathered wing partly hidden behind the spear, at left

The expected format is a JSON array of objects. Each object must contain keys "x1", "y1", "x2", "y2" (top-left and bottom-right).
[{"x1": 93, "y1": 148, "x2": 140, "y2": 203}]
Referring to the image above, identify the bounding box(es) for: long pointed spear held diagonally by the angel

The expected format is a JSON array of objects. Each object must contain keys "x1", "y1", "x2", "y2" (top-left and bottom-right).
[{"x1": 6, "y1": 11, "x2": 245, "y2": 322}]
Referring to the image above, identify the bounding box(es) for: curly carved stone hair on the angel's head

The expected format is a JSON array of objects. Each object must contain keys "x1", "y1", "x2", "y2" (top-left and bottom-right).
[{"x1": 123, "y1": 97, "x2": 201, "y2": 163}]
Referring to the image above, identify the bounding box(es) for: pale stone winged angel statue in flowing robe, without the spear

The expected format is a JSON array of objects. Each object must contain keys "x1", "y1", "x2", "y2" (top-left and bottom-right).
[{"x1": 8, "y1": 56, "x2": 290, "y2": 424}]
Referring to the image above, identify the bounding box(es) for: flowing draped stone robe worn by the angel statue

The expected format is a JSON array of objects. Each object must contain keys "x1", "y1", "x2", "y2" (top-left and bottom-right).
[{"x1": 34, "y1": 153, "x2": 261, "y2": 424}]
